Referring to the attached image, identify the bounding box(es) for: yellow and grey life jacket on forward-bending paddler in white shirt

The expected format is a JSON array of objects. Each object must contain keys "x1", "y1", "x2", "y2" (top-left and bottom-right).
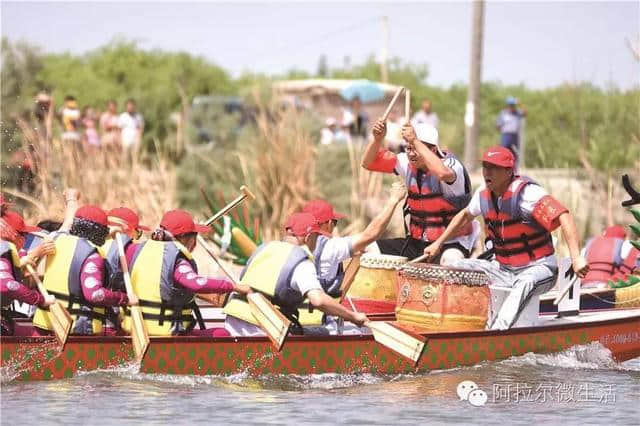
[{"x1": 224, "y1": 241, "x2": 313, "y2": 325}]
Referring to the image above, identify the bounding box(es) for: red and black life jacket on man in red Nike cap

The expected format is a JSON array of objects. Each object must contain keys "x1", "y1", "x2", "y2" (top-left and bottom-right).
[{"x1": 480, "y1": 176, "x2": 554, "y2": 267}]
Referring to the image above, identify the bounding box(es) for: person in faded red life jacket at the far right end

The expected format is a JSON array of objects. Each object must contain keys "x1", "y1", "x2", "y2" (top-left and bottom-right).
[{"x1": 580, "y1": 225, "x2": 633, "y2": 288}]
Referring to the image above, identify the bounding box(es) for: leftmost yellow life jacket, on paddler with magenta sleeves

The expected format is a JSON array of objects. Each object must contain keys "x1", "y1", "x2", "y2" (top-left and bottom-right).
[{"x1": 33, "y1": 234, "x2": 107, "y2": 334}]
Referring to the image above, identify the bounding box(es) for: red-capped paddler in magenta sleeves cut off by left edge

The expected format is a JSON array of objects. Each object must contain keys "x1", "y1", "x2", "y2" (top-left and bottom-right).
[{"x1": 0, "y1": 210, "x2": 56, "y2": 335}]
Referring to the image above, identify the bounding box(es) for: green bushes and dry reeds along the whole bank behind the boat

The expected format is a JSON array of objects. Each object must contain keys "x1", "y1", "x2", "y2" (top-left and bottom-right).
[{"x1": 0, "y1": 38, "x2": 640, "y2": 253}]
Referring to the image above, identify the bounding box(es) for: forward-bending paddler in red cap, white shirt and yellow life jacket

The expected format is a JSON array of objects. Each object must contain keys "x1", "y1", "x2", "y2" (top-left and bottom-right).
[{"x1": 224, "y1": 213, "x2": 367, "y2": 336}]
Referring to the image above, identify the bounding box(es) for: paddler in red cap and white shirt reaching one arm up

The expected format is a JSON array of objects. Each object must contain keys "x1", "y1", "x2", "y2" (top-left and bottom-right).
[{"x1": 302, "y1": 182, "x2": 407, "y2": 297}]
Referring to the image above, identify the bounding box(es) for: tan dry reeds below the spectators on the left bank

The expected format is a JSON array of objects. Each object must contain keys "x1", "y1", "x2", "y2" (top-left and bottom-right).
[{"x1": 3, "y1": 120, "x2": 176, "y2": 224}]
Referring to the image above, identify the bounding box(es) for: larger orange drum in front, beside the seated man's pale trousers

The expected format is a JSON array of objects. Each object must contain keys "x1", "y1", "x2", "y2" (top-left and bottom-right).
[{"x1": 396, "y1": 263, "x2": 490, "y2": 331}]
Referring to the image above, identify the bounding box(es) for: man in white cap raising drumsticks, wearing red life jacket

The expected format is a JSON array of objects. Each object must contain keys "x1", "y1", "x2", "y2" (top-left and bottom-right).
[{"x1": 362, "y1": 119, "x2": 479, "y2": 264}]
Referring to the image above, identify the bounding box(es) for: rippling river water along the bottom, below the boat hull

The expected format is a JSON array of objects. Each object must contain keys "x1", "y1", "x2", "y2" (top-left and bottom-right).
[{"x1": 0, "y1": 344, "x2": 640, "y2": 426}]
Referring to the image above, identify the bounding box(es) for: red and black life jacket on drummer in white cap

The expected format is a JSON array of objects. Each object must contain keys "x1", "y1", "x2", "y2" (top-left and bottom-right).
[{"x1": 404, "y1": 153, "x2": 473, "y2": 241}]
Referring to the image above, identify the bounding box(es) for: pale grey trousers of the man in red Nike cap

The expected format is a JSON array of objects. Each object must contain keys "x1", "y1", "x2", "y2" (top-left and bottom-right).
[{"x1": 451, "y1": 256, "x2": 558, "y2": 330}]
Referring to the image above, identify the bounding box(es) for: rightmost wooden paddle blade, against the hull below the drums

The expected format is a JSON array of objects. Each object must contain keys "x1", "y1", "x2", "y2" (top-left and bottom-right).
[{"x1": 365, "y1": 321, "x2": 427, "y2": 366}]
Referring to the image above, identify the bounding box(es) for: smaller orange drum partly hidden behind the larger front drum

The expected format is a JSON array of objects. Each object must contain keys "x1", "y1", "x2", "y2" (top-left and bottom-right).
[{"x1": 345, "y1": 253, "x2": 407, "y2": 314}]
